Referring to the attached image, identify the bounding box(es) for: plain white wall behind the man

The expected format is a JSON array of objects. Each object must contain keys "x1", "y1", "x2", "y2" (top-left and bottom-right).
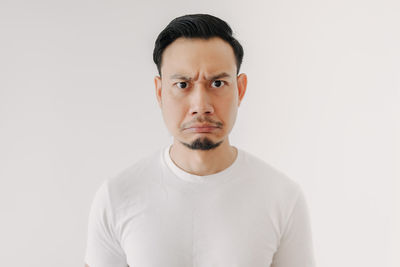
[{"x1": 0, "y1": 0, "x2": 400, "y2": 267}]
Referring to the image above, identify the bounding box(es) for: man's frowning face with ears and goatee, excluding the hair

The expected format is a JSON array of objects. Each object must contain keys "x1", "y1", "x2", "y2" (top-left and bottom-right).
[{"x1": 154, "y1": 38, "x2": 247, "y2": 150}]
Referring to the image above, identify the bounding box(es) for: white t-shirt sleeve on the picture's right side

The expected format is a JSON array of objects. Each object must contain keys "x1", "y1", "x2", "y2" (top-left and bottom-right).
[{"x1": 271, "y1": 187, "x2": 315, "y2": 267}]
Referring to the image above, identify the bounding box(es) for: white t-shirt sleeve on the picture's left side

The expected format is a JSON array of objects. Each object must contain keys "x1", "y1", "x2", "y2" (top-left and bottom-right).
[{"x1": 85, "y1": 180, "x2": 128, "y2": 267}]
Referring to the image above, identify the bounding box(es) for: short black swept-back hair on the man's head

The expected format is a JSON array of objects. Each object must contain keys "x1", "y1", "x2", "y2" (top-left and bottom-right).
[{"x1": 153, "y1": 14, "x2": 243, "y2": 76}]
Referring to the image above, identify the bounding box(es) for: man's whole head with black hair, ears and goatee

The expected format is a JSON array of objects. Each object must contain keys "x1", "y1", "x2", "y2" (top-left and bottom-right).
[{"x1": 153, "y1": 14, "x2": 247, "y2": 150}]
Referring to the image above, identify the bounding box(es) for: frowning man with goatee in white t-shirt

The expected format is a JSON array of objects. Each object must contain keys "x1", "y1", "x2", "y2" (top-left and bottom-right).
[{"x1": 85, "y1": 14, "x2": 315, "y2": 267}]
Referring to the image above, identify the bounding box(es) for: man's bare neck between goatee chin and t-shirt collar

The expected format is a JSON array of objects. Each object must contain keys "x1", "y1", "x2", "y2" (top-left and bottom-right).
[{"x1": 170, "y1": 138, "x2": 238, "y2": 176}]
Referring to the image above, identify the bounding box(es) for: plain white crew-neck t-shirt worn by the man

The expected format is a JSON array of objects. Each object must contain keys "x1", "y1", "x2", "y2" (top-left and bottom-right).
[{"x1": 85, "y1": 145, "x2": 315, "y2": 267}]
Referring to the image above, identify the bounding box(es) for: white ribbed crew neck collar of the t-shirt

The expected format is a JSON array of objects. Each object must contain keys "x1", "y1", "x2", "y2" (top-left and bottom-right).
[{"x1": 162, "y1": 145, "x2": 243, "y2": 184}]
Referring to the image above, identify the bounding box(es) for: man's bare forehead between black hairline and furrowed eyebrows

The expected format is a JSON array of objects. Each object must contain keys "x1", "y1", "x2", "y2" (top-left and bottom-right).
[{"x1": 161, "y1": 37, "x2": 236, "y2": 77}]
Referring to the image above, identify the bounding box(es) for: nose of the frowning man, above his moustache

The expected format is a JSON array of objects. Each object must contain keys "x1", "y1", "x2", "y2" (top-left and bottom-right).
[{"x1": 190, "y1": 83, "x2": 214, "y2": 115}]
